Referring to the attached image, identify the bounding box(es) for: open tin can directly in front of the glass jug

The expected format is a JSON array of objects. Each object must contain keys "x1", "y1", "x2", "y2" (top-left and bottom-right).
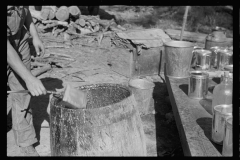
[{"x1": 212, "y1": 104, "x2": 232, "y2": 145}]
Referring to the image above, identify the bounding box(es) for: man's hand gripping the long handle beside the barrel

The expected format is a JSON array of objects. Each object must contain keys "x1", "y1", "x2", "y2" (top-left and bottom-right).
[{"x1": 25, "y1": 76, "x2": 47, "y2": 96}]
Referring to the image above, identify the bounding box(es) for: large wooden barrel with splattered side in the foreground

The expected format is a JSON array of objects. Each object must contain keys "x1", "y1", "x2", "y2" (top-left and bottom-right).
[{"x1": 50, "y1": 84, "x2": 147, "y2": 156}]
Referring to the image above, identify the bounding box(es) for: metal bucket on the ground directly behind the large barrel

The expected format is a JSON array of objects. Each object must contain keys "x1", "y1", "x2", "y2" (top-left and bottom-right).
[{"x1": 129, "y1": 79, "x2": 155, "y2": 115}]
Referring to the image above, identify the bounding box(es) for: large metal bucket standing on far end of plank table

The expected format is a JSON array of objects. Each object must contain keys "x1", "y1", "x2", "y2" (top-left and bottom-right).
[{"x1": 165, "y1": 41, "x2": 194, "y2": 78}]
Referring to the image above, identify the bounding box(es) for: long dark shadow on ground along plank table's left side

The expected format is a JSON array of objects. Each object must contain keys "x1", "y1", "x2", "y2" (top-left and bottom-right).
[{"x1": 153, "y1": 82, "x2": 184, "y2": 157}]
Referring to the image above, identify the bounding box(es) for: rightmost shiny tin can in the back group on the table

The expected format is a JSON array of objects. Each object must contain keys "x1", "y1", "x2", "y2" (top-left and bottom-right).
[{"x1": 217, "y1": 48, "x2": 233, "y2": 70}]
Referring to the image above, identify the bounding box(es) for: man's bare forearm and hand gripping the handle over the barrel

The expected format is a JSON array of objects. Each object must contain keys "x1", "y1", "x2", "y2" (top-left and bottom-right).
[{"x1": 7, "y1": 39, "x2": 46, "y2": 96}]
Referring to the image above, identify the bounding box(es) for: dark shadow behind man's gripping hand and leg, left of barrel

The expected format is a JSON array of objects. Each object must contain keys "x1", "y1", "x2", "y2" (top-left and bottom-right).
[{"x1": 29, "y1": 78, "x2": 63, "y2": 147}]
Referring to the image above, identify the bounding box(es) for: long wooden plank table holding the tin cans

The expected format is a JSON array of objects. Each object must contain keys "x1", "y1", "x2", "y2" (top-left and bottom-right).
[{"x1": 165, "y1": 75, "x2": 222, "y2": 156}]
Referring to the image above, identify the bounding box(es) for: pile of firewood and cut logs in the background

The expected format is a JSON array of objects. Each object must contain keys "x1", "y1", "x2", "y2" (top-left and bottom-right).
[{"x1": 29, "y1": 6, "x2": 126, "y2": 39}]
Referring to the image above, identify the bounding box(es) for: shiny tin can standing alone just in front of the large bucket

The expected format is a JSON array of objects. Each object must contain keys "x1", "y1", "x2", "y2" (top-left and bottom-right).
[{"x1": 188, "y1": 71, "x2": 209, "y2": 99}]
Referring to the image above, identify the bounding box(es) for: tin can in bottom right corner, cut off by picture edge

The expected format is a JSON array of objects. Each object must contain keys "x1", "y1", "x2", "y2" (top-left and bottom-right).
[{"x1": 222, "y1": 116, "x2": 233, "y2": 156}]
